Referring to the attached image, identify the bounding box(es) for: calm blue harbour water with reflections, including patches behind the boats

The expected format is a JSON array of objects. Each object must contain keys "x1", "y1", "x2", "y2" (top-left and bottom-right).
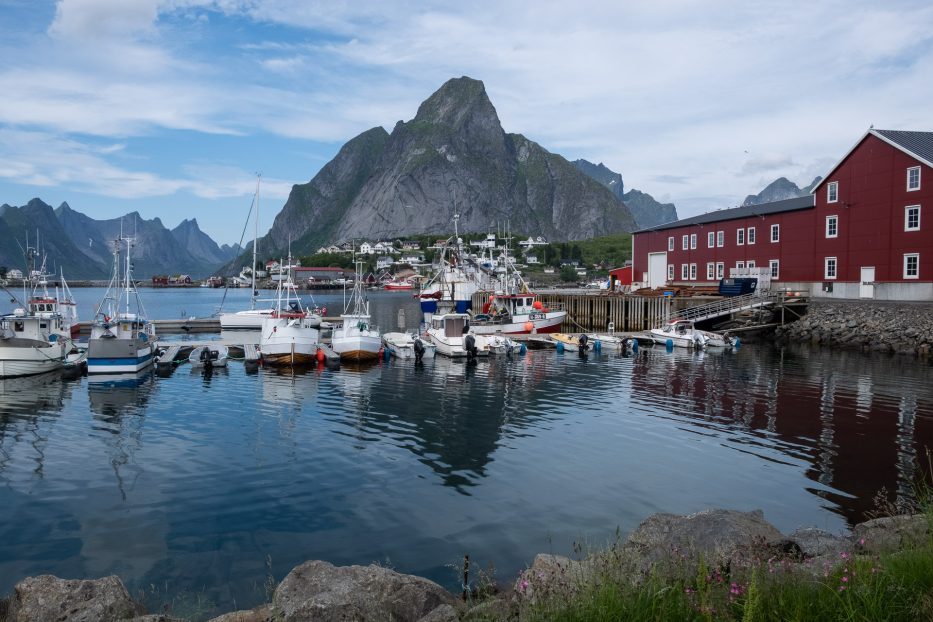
[{"x1": 0, "y1": 290, "x2": 933, "y2": 610}]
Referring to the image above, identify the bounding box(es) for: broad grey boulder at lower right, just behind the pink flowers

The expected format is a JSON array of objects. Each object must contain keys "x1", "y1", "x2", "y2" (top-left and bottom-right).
[{"x1": 624, "y1": 510, "x2": 783, "y2": 575}]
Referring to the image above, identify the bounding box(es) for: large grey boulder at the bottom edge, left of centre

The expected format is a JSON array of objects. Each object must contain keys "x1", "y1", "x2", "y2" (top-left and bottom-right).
[{"x1": 272, "y1": 561, "x2": 456, "y2": 622}]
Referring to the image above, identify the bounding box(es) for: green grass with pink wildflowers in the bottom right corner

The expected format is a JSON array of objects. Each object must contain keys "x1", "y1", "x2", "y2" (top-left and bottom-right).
[{"x1": 517, "y1": 451, "x2": 933, "y2": 622}]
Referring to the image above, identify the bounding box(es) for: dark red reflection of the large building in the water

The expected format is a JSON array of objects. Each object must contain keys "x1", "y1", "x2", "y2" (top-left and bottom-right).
[{"x1": 632, "y1": 348, "x2": 933, "y2": 524}]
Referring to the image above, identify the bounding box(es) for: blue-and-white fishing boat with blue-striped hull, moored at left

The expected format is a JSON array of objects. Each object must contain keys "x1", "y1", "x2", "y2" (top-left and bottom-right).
[{"x1": 87, "y1": 236, "x2": 155, "y2": 375}]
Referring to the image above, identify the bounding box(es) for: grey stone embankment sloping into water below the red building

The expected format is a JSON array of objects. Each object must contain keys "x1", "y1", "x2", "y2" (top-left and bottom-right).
[{"x1": 774, "y1": 301, "x2": 933, "y2": 357}]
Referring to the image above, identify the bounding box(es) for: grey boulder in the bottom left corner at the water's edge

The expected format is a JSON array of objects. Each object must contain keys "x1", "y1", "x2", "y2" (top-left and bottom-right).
[{"x1": 7, "y1": 575, "x2": 145, "y2": 622}]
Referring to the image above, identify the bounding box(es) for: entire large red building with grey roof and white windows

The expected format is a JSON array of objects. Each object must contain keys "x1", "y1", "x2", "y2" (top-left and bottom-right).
[{"x1": 632, "y1": 129, "x2": 933, "y2": 300}]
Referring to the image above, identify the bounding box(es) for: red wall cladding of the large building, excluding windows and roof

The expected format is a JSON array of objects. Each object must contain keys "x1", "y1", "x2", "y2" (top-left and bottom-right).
[{"x1": 633, "y1": 134, "x2": 933, "y2": 292}]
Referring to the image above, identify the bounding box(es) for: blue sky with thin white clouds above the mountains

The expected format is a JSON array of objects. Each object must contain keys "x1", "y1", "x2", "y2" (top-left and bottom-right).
[{"x1": 0, "y1": 0, "x2": 933, "y2": 249}]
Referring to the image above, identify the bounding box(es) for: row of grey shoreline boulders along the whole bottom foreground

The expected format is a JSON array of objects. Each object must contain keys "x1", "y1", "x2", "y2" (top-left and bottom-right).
[{"x1": 0, "y1": 510, "x2": 933, "y2": 622}]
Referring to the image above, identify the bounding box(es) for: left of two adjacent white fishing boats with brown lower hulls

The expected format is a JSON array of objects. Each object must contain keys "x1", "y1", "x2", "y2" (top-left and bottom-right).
[{"x1": 259, "y1": 266, "x2": 321, "y2": 367}]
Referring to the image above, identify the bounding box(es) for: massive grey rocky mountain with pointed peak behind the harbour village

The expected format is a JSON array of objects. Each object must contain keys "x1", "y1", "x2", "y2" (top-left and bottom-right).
[{"x1": 263, "y1": 77, "x2": 635, "y2": 253}]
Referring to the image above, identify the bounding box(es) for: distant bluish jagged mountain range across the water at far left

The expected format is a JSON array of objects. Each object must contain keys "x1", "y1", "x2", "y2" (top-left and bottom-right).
[{"x1": 0, "y1": 199, "x2": 241, "y2": 279}]
